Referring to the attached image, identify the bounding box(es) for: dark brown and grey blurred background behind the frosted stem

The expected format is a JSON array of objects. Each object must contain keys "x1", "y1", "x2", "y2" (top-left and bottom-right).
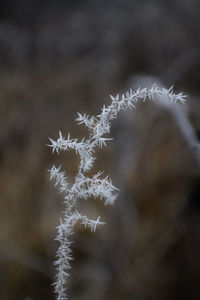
[{"x1": 0, "y1": 0, "x2": 200, "y2": 300}]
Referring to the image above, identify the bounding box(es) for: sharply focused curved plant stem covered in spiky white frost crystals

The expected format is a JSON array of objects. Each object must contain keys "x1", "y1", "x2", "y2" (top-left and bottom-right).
[{"x1": 49, "y1": 85, "x2": 185, "y2": 300}]
